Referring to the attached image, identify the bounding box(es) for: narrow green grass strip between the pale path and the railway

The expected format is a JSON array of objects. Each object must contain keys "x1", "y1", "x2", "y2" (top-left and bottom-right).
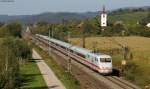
[{"x1": 34, "y1": 45, "x2": 80, "y2": 89}]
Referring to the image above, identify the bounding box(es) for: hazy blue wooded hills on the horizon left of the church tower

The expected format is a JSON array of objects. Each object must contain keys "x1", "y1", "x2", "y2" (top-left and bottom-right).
[{"x1": 0, "y1": 12, "x2": 98, "y2": 23}]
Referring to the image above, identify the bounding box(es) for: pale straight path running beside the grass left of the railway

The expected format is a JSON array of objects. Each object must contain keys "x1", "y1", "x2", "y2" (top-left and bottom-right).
[{"x1": 32, "y1": 49, "x2": 66, "y2": 89}]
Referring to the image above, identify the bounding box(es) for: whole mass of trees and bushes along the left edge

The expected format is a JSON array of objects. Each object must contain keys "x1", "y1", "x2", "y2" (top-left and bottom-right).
[{"x1": 0, "y1": 23, "x2": 31, "y2": 89}]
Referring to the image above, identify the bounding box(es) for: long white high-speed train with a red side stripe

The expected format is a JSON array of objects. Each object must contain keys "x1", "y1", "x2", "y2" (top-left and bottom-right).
[{"x1": 36, "y1": 34, "x2": 112, "y2": 74}]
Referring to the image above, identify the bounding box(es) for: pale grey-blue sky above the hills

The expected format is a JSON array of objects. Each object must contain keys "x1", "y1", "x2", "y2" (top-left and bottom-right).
[{"x1": 0, "y1": 0, "x2": 150, "y2": 15}]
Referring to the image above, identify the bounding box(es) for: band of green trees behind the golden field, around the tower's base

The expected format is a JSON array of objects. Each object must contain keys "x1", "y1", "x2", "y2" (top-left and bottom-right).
[{"x1": 29, "y1": 14, "x2": 150, "y2": 40}]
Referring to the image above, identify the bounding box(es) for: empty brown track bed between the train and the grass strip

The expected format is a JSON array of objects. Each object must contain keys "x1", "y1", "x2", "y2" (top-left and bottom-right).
[{"x1": 35, "y1": 40, "x2": 110, "y2": 89}]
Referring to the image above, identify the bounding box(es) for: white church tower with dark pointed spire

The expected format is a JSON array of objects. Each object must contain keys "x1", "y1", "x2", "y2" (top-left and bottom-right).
[{"x1": 101, "y1": 6, "x2": 107, "y2": 27}]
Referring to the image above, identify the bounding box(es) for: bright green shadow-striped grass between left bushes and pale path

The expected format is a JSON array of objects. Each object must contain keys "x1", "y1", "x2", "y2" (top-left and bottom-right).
[{"x1": 20, "y1": 60, "x2": 47, "y2": 89}]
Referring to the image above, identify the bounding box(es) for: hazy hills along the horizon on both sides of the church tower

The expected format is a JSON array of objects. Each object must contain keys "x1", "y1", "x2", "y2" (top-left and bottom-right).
[{"x1": 0, "y1": 6, "x2": 150, "y2": 24}]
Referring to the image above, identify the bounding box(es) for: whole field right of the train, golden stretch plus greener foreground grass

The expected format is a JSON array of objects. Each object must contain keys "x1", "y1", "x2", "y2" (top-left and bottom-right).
[{"x1": 71, "y1": 36, "x2": 150, "y2": 88}]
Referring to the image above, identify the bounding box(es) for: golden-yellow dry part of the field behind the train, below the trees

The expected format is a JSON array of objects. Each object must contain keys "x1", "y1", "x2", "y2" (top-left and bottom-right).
[{"x1": 71, "y1": 36, "x2": 150, "y2": 59}]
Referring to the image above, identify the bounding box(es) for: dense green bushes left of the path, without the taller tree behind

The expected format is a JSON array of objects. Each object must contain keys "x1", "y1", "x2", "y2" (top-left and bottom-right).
[{"x1": 0, "y1": 37, "x2": 31, "y2": 89}]
